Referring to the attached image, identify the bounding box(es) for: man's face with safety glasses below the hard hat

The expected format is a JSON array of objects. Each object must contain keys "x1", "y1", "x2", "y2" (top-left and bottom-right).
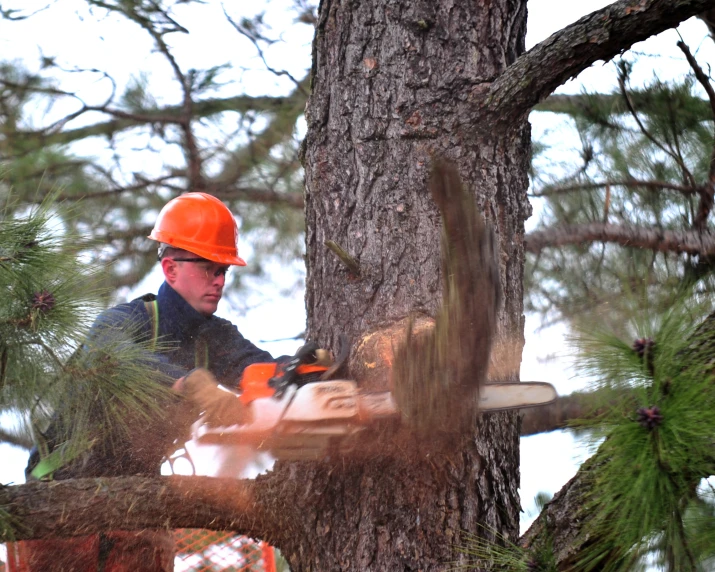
[{"x1": 161, "y1": 253, "x2": 230, "y2": 316}]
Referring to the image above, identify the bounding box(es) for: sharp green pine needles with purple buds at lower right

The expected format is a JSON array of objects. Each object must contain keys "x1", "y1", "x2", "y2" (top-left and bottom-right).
[{"x1": 578, "y1": 297, "x2": 715, "y2": 571}]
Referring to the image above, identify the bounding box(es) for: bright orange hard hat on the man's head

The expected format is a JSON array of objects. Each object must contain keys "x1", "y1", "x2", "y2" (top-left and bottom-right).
[{"x1": 149, "y1": 193, "x2": 246, "y2": 266}]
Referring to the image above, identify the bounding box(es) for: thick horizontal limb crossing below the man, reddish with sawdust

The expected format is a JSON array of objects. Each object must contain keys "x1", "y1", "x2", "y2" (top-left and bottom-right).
[{"x1": 0, "y1": 476, "x2": 272, "y2": 542}]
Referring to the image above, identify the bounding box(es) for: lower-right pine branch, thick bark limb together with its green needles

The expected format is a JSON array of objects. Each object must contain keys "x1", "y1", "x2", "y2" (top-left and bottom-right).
[{"x1": 520, "y1": 295, "x2": 715, "y2": 571}]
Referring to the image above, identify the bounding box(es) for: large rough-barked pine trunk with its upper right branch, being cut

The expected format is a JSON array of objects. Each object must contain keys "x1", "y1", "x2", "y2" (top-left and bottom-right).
[{"x1": 0, "y1": 0, "x2": 715, "y2": 571}]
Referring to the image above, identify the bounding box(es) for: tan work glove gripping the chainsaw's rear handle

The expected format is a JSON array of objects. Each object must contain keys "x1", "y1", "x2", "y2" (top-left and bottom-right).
[{"x1": 174, "y1": 367, "x2": 253, "y2": 427}]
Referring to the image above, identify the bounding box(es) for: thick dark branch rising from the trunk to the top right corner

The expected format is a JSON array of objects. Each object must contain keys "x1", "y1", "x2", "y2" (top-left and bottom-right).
[{"x1": 484, "y1": 0, "x2": 715, "y2": 121}]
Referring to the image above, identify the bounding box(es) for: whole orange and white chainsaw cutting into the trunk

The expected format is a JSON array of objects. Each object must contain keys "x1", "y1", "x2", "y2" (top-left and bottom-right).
[{"x1": 196, "y1": 344, "x2": 557, "y2": 460}]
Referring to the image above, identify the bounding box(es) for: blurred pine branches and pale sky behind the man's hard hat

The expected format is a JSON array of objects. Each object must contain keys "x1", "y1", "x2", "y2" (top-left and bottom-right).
[{"x1": 0, "y1": 0, "x2": 313, "y2": 304}]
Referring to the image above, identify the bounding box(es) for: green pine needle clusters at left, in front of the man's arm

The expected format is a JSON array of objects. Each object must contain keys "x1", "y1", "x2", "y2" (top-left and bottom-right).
[{"x1": 0, "y1": 199, "x2": 170, "y2": 541}]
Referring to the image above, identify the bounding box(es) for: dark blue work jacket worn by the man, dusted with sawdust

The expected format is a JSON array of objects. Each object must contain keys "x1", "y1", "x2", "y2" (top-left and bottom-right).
[{"x1": 26, "y1": 282, "x2": 275, "y2": 479}]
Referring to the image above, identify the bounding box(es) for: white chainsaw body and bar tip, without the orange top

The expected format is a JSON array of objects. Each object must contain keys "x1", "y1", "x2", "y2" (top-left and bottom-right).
[{"x1": 197, "y1": 380, "x2": 556, "y2": 460}]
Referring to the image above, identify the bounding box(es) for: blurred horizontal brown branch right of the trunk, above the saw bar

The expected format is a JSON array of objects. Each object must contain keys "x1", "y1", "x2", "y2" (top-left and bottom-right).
[{"x1": 524, "y1": 222, "x2": 715, "y2": 256}]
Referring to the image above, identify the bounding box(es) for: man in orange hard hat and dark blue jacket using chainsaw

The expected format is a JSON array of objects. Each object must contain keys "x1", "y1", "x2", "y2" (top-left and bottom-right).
[{"x1": 24, "y1": 193, "x2": 290, "y2": 572}]
